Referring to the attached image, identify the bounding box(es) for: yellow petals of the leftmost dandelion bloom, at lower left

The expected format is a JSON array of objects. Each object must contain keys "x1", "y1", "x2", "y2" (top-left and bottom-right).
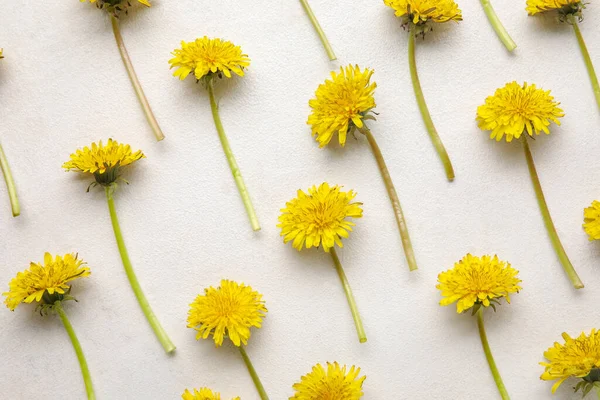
[{"x1": 3, "y1": 253, "x2": 90, "y2": 311}]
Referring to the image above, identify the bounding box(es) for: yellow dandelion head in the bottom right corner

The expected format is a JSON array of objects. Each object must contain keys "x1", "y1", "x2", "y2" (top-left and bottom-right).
[{"x1": 540, "y1": 329, "x2": 600, "y2": 393}]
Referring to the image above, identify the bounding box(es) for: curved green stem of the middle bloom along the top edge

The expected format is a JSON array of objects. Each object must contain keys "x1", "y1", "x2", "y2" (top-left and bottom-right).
[{"x1": 408, "y1": 28, "x2": 454, "y2": 181}]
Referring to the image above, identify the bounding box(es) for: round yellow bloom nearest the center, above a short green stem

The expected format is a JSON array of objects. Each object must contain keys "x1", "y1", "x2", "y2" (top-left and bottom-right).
[{"x1": 277, "y1": 182, "x2": 362, "y2": 252}]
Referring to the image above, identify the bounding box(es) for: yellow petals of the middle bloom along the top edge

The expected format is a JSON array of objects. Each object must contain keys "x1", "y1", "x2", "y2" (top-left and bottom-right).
[{"x1": 383, "y1": 0, "x2": 462, "y2": 25}]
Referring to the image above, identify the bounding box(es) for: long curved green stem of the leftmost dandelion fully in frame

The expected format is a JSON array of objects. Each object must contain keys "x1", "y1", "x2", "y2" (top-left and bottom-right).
[{"x1": 106, "y1": 186, "x2": 175, "y2": 353}]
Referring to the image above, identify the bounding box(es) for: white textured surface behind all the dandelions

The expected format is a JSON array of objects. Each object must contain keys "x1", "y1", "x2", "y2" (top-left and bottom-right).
[{"x1": 0, "y1": 0, "x2": 600, "y2": 400}]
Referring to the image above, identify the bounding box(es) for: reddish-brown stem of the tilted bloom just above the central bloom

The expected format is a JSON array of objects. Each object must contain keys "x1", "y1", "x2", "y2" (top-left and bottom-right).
[{"x1": 361, "y1": 128, "x2": 418, "y2": 271}]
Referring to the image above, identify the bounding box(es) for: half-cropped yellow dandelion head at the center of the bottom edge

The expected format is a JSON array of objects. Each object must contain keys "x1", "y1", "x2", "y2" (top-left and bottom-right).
[{"x1": 290, "y1": 362, "x2": 367, "y2": 400}]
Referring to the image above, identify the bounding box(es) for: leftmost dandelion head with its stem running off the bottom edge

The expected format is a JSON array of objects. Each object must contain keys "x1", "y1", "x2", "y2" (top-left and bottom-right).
[{"x1": 3, "y1": 253, "x2": 95, "y2": 400}]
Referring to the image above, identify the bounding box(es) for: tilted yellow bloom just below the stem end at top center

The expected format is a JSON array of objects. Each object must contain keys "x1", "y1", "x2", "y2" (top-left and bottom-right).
[{"x1": 307, "y1": 65, "x2": 377, "y2": 147}]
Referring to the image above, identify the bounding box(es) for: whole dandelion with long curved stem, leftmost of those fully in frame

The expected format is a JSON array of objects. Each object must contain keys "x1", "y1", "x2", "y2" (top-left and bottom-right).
[{"x1": 63, "y1": 139, "x2": 175, "y2": 353}]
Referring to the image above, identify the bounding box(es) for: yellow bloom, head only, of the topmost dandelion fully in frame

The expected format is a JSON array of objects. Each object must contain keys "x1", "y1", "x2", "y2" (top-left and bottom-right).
[{"x1": 169, "y1": 36, "x2": 250, "y2": 80}]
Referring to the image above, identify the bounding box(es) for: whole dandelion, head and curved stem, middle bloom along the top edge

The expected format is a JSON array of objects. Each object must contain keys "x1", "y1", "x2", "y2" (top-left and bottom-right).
[{"x1": 383, "y1": 0, "x2": 462, "y2": 181}]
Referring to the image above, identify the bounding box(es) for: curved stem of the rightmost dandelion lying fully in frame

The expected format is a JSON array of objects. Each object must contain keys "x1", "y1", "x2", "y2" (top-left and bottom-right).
[{"x1": 522, "y1": 137, "x2": 583, "y2": 289}]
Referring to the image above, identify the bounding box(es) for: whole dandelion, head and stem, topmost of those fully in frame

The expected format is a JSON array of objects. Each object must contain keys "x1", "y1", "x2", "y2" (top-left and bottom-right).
[{"x1": 169, "y1": 36, "x2": 260, "y2": 231}]
